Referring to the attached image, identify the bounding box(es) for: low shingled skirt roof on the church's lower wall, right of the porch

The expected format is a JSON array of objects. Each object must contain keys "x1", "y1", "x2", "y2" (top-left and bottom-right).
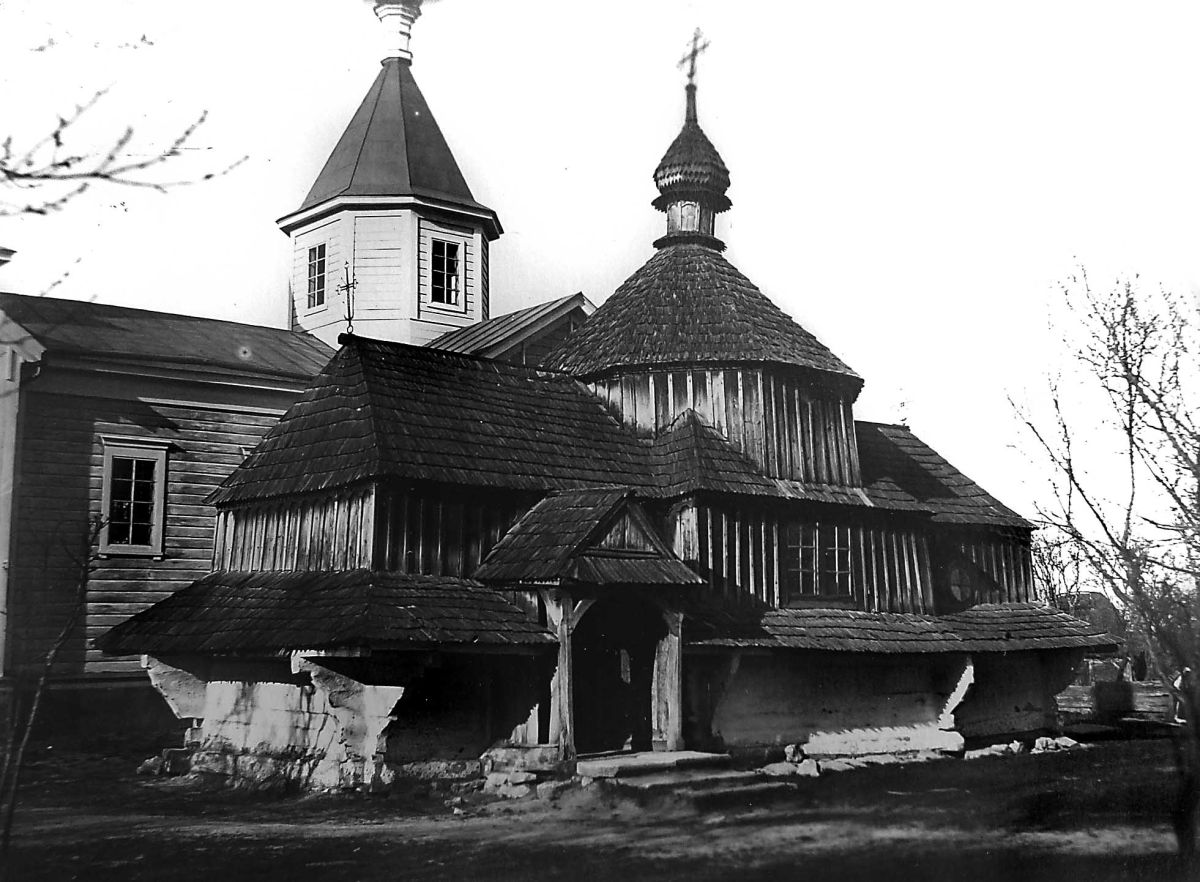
[{"x1": 684, "y1": 604, "x2": 1116, "y2": 654}]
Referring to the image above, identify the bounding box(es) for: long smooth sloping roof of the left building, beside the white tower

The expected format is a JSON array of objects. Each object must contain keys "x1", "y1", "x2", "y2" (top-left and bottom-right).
[{"x1": 0, "y1": 293, "x2": 334, "y2": 380}]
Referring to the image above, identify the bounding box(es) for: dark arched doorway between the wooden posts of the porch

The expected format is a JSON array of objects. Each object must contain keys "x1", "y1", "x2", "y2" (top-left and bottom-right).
[{"x1": 571, "y1": 598, "x2": 667, "y2": 754}]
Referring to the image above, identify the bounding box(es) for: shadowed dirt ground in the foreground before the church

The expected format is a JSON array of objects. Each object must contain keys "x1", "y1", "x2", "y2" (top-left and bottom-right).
[{"x1": 2, "y1": 739, "x2": 1190, "y2": 882}]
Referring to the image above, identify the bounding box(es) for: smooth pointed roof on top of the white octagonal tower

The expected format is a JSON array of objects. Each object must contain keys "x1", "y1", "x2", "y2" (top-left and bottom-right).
[{"x1": 285, "y1": 58, "x2": 498, "y2": 232}]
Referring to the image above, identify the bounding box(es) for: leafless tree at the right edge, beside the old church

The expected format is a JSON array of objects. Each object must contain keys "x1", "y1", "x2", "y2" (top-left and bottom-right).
[{"x1": 1024, "y1": 271, "x2": 1200, "y2": 864}]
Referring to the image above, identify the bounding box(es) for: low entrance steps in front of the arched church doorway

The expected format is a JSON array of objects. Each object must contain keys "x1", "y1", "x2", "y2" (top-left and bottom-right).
[{"x1": 575, "y1": 750, "x2": 798, "y2": 810}]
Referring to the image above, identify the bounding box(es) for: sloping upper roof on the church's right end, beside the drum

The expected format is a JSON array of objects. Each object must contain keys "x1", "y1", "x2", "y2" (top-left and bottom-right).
[{"x1": 854, "y1": 420, "x2": 1033, "y2": 529}]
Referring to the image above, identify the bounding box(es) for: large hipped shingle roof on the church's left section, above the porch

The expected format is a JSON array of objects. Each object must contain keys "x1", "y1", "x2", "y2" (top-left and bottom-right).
[{"x1": 210, "y1": 336, "x2": 650, "y2": 503}]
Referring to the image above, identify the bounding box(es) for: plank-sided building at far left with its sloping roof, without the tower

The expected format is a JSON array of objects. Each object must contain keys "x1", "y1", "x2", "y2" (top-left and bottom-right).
[{"x1": 0, "y1": 294, "x2": 331, "y2": 720}]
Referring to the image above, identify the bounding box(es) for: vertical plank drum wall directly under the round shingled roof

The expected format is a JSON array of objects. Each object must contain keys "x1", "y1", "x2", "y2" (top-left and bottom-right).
[{"x1": 590, "y1": 368, "x2": 863, "y2": 487}]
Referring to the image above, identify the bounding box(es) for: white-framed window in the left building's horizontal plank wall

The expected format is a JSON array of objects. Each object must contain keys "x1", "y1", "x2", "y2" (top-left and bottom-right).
[{"x1": 100, "y1": 437, "x2": 168, "y2": 556}]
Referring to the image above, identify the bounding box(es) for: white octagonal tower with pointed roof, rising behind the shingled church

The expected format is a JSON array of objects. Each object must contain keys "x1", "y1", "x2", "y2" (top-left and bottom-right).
[{"x1": 278, "y1": 0, "x2": 503, "y2": 346}]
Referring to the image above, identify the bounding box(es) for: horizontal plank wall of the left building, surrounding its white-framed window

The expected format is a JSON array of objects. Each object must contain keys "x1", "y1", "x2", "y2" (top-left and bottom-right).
[{"x1": 6, "y1": 390, "x2": 277, "y2": 674}]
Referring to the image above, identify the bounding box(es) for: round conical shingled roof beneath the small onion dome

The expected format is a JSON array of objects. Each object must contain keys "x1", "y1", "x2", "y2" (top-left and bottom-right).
[{"x1": 545, "y1": 242, "x2": 862, "y2": 390}]
